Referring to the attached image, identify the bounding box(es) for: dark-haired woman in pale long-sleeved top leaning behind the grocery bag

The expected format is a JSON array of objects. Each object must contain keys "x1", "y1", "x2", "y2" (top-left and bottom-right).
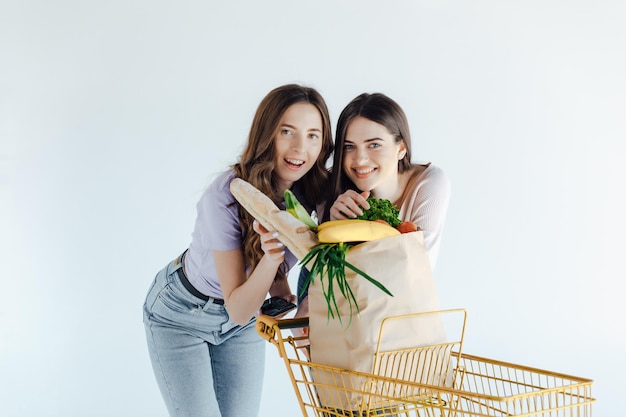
[{"x1": 296, "y1": 93, "x2": 451, "y2": 316}]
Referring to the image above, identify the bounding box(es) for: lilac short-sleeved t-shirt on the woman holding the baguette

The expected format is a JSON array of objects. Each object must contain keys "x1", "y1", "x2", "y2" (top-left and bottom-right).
[{"x1": 185, "y1": 170, "x2": 297, "y2": 298}]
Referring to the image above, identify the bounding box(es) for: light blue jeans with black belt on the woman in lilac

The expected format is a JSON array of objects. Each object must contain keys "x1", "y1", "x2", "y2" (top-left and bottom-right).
[{"x1": 143, "y1": 256, "x2": 266, "y2": 417}]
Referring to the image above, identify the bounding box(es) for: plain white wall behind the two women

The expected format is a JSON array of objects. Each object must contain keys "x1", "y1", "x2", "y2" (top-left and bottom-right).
[{"x1": 0, "y1": 0, "x2": 626, "y2": 417}]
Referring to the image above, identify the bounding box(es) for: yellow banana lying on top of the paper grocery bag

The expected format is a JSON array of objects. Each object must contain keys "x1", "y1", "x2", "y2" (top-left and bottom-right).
[{"x1": 317, "y1": 219, "x2": 400, "y2": 243}]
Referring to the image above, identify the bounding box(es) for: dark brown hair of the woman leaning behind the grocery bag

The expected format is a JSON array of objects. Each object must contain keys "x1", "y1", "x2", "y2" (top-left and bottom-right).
[{"x1": 324, "y1": 93, "x2": 412, "y2": 220}]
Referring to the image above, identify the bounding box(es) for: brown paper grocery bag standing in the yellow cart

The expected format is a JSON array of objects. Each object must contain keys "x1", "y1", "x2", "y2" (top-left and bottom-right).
[{"x1": 309, "y1": 231, "x2": 448, "y2": 410}]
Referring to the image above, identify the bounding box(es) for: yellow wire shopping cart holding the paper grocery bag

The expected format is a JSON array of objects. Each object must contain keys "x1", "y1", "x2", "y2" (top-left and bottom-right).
[{"x1": 257, "y1": 309, "x2": 595, "y2": 417}]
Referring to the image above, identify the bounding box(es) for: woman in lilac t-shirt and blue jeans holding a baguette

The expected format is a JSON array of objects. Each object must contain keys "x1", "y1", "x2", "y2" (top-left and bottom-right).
[{"x1": 144, "y1": 84, "x2": 333, "y2": 417}]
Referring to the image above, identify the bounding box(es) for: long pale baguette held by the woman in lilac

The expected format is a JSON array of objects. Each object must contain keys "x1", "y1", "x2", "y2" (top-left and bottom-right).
[{"x1": 230, "y1": 178, "x2": 318, "y2": 260}]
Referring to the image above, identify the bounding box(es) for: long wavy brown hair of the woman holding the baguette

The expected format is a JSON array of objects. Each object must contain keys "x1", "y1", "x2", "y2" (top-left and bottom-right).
[{"x1": 232, "y1": 84, "x2": 333, "y2": 278}]
